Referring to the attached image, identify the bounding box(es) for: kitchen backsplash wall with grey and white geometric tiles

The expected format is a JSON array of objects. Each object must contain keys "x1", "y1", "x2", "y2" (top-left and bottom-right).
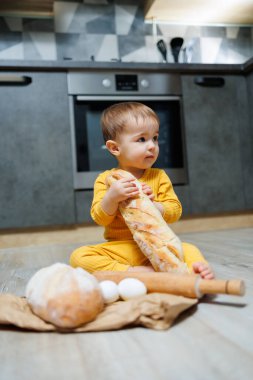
[{"x1": 0, "y1": 0, "x2": 253, "y2": 63}]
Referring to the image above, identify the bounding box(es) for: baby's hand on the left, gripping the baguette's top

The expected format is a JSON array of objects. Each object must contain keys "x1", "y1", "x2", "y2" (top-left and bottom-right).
[{"x1": 107, "y1": 178, "x2": 139, "y2": 203}]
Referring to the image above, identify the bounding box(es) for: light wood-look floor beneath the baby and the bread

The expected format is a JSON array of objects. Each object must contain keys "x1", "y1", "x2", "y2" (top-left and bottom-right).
[{"x1": 0, "y1": 227, "x2": 253, "y2": 380}]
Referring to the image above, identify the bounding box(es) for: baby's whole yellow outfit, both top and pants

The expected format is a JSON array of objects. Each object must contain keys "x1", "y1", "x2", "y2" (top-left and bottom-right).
[{"x1": 70, "y1": 168, "x2": 206, "y2": 272}]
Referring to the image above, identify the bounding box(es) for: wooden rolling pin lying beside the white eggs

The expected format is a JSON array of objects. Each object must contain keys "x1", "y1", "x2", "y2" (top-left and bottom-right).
[{"x1": 93, "y1": 271, "x2": 245, "y2": 298}]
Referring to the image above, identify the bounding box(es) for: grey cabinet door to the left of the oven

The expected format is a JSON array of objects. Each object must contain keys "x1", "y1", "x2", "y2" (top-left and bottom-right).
[{"x1": 0, "y1": 72, "x2": 74, "y2": 228}]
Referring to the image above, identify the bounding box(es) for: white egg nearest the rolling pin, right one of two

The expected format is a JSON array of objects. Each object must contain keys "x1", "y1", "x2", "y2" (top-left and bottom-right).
[{"x1": 118, "y1": 278, "x2": 147, "y2": 301}]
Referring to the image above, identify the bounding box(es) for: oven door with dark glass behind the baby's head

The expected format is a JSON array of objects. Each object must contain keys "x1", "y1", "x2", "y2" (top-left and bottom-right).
[{"x1": 70, "y1": 95, "x2": 187, "y2": 190}]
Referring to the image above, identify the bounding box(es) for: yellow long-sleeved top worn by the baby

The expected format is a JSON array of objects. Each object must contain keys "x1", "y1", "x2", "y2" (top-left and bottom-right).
[{"x1": 91, "y1": 168, "x2": 182, "y2": 241}]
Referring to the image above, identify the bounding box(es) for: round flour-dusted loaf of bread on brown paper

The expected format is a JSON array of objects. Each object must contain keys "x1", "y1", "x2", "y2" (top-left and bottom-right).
[{"x1": 26, "y1": 263, "x2": 104, "y2": 328}]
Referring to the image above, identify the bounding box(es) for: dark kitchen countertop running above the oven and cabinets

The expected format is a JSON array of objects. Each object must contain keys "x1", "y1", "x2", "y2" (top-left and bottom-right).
[{"x1": 0, "y1": 58, "x2": 253, "y2": 75}]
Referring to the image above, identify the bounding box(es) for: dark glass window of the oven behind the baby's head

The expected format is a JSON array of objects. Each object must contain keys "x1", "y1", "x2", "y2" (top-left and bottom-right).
[{"x1": 74, "y1": 99, "x2": 184, "y2": 172}]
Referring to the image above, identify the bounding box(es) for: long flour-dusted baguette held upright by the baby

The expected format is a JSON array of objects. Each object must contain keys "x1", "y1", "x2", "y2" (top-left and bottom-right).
[{"x1": 106, "y1": 169, "x2": 188, "y2": 273}]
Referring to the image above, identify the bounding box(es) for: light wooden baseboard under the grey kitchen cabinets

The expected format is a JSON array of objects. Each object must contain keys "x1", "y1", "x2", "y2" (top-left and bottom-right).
[{"x1": 0, "y1": 212, "x2": 253, "y2": 248}]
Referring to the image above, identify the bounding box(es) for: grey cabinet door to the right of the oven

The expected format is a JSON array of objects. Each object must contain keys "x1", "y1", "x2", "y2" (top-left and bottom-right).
[{"x1": 182, "y1": 76, "x2": 248, "y2": 214}]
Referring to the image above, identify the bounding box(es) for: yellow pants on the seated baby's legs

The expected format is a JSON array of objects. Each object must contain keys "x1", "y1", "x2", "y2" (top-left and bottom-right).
[{"x1": 70, "y1": 240, "x2": 206, "y2": 273}]
